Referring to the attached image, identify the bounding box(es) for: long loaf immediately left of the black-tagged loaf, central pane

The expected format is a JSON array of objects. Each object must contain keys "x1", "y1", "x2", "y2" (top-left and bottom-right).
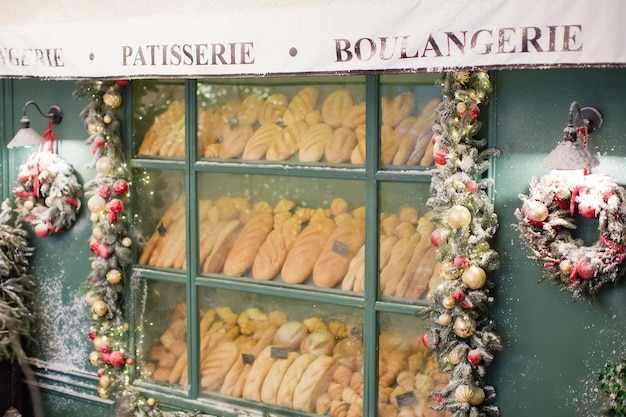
[{"x1": 281, "y1": 214, "x2": 337, "y2": 284}]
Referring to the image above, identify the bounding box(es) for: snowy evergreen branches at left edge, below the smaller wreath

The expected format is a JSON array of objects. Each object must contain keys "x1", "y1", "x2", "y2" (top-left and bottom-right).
[{"x1": 0, "y1": 200, "x2": 35, "y2": 361}]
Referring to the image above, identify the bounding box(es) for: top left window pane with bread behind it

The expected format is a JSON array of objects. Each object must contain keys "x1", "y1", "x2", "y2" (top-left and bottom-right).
[{"x1": 132, "y1": 80, "x2": 185, "y2": 158}]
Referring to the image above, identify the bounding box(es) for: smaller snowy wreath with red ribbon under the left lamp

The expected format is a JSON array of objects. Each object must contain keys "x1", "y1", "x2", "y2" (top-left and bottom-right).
[{"x1": 13, "y1": 151, "x2": 82, "y2": 237}]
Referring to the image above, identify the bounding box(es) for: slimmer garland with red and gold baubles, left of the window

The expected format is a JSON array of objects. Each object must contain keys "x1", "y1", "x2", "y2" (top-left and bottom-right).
[{"x1": 74, "y1": 80, "x2": 205, "y2": 417}]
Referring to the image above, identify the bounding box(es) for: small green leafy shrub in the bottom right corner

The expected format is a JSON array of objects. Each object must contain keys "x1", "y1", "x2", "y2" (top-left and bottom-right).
[{"x1": 598, "y1": 359, "x2": 626, "y2": 417}]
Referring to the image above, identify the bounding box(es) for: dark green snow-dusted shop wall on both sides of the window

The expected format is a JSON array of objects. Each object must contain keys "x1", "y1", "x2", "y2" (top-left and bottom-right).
[{"x1": 0, "y1": 69, "x2": 626, "y2": 417}]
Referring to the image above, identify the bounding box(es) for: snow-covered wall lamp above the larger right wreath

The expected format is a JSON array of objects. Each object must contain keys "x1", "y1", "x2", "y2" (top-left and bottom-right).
[{"x1": 541, "y1": 101, "x2": 602, "y2": 171}]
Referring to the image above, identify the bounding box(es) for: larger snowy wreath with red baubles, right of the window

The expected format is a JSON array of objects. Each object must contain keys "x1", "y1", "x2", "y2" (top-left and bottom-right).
[{"x1": 515, "y1": 171, "x2": 626, "y2": 300}]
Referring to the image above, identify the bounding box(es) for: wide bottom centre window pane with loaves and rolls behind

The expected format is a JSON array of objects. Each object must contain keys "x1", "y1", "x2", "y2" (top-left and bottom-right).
[{"x1": 199, "y1": 288, "x2": 363, "y2": 415}]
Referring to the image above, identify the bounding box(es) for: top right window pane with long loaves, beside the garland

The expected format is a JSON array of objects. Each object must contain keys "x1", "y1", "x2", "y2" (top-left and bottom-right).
[{"x1": 380, "y1": 74, "x2": 442, "y2": 169}]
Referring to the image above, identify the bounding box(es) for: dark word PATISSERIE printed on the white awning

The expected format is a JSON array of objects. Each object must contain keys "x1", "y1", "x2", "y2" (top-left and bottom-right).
[{"x1": 122, "y1": 42, "x2": 254, "y2": 66}]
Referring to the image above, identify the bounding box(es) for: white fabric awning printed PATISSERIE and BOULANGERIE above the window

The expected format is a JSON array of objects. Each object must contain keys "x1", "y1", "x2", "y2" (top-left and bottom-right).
[{"x1": 0, "y1": 0, "x2": 626, "y2": 79}]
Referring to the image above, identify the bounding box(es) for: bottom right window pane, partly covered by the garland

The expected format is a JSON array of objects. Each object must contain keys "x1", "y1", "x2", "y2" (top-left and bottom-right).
[{"x1": 378, "y1": 313, "x2": 450, "y2": 417}]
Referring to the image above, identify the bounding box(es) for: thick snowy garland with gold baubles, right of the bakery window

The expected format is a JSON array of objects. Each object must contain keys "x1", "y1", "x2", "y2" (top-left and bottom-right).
[{"x1": 422, "y1": 71, "x2": 502, "y2": 417}]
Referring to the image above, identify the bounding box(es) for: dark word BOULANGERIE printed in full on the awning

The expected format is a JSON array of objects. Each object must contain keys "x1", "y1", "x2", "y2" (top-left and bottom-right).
[{"x1": 335, "y1": 25, "x2": 583, "y2": 62}]
